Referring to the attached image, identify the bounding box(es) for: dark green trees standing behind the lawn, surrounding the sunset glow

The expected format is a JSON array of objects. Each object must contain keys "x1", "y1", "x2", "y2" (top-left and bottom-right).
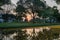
[{"x1": 0, "y1": 0, "x2": 60, "y2": 26}]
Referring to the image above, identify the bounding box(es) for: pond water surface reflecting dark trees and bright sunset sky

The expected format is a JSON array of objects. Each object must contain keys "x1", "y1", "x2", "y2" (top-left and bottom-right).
[{"x1": 0, "y1": 27, "x2": 60, "y2": 40}]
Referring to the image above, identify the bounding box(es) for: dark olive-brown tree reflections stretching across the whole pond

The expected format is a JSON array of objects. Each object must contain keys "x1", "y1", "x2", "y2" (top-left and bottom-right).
[{"x1": 1, "y1": 28, "x2": 60, "y2": 40}]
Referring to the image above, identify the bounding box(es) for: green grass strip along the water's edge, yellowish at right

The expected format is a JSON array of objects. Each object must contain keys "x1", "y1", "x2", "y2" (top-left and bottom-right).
[{"x1": 0, "y1": 23, "x2": 60, "y2": 28}]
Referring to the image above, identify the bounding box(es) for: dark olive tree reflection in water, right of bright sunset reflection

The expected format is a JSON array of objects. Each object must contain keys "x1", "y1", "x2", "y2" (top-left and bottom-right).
[{"x1": 32, "y1": 29, "x2": 59, "y2": 40}]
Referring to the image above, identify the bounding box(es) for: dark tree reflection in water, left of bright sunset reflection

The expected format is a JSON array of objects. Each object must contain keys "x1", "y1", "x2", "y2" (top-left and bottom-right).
[{"x1": 2, "y1": 29, "x2": 28, "y2": 40}]
